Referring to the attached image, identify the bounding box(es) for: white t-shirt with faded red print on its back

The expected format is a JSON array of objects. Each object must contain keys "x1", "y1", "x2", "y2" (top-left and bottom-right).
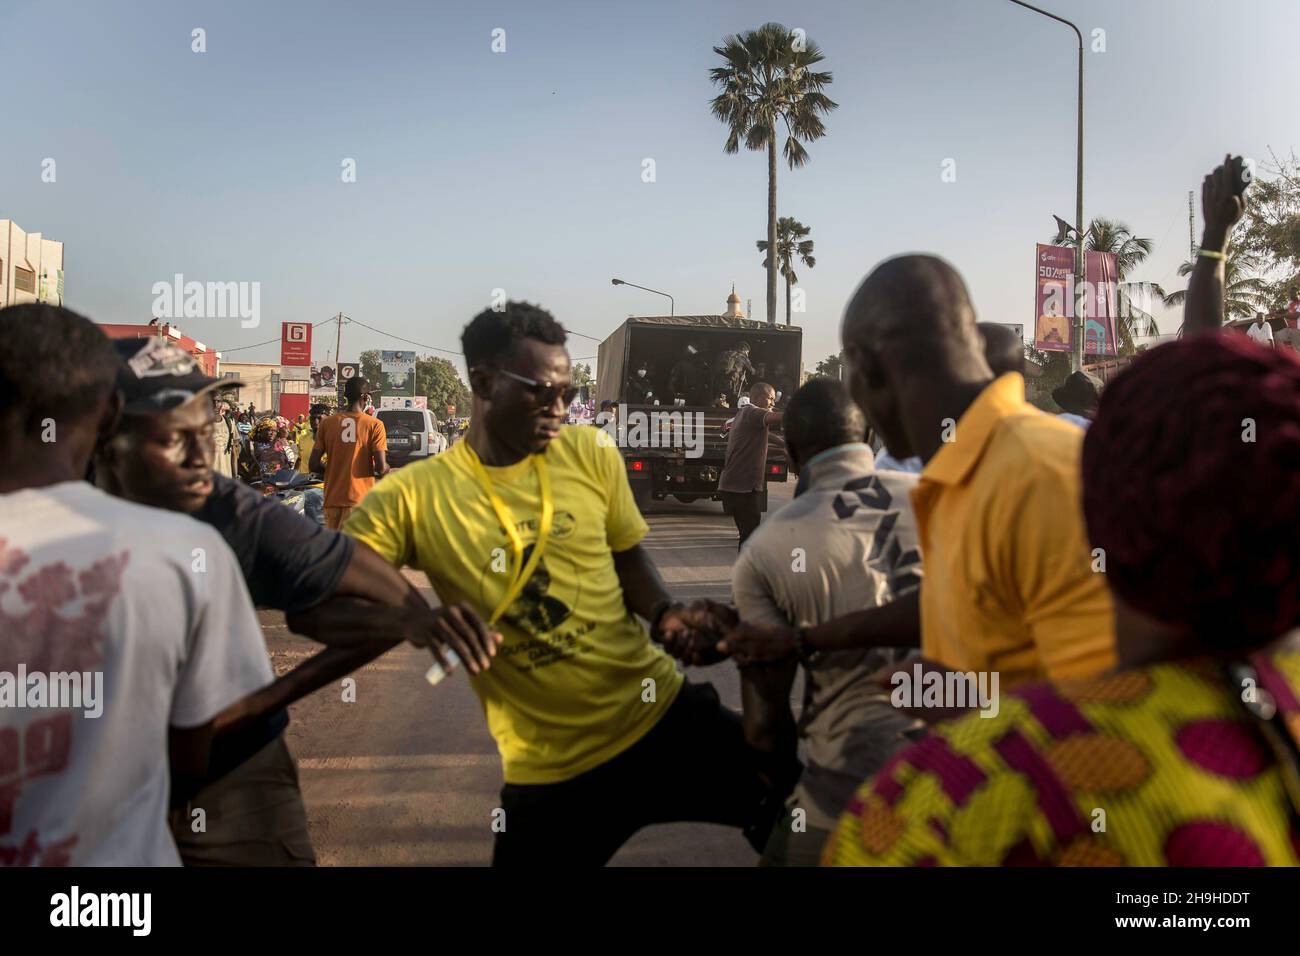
[{"x1": 0, "y1": 481, "x2": 274, "y2": 866}]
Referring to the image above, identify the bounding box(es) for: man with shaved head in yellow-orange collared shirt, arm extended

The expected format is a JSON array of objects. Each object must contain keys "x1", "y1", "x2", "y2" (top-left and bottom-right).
[{"x1": 720, "y1": 255, "x2": 1115, "y2": 697}]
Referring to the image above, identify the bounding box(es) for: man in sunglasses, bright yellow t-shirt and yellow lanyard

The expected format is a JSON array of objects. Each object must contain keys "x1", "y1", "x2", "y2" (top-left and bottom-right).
[{"x1": 343, "y1": 302, "x2": 793, "y2": 865}]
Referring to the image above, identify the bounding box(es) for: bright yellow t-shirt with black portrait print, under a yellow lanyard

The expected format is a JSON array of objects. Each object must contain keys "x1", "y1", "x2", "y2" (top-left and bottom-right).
[{"x1": 343, "y1": 425, "x2": 681, "y2": 784}]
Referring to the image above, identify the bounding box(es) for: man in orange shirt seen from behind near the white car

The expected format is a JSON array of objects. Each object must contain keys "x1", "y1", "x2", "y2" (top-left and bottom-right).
[{"x1": 311, "y1": 378, "x2": 389, "y2": 531}]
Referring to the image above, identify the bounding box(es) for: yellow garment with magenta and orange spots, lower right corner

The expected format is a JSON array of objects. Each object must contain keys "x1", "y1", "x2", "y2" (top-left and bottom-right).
[{"x1": 823, "y1": 649, "x2": 1300, "y2": 866}]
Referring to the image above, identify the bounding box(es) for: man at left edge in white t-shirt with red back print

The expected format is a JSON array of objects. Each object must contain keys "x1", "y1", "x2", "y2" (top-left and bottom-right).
[{"x1": 0, "y1": 303, "x2": 273, "y2": 866}]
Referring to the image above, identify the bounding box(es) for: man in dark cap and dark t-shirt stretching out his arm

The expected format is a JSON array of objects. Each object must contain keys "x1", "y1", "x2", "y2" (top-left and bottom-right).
[{"x1": 95, "y1": 338, "x2": 499, "y2": 866}]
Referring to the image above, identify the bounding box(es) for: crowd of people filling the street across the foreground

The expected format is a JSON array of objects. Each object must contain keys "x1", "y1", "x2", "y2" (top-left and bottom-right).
[{"x1": 0, "y1": 151, "x2": 1300, "y2": 866}]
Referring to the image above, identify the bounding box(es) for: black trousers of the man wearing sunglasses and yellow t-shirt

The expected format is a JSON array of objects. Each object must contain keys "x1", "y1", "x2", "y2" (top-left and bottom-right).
[{"x1": 493, "y1": 682, "x2": 798, "y2": 868}]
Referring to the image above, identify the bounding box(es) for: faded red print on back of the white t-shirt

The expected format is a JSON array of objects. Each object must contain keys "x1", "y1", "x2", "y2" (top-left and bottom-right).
[{"x1": 0, "y1": 538, "x2": 130, "y2": 866}]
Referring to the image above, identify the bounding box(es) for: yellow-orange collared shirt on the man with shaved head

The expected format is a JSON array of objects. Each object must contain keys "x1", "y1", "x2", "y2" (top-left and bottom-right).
[{"x1": 911, "y1": 372, "x2": 1115, "y2": 687}]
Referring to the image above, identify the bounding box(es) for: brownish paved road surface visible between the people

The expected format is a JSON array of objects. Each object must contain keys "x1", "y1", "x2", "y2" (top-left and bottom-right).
[{"x1": 261, "y1": 483, "x2": 794, "y2": 866}]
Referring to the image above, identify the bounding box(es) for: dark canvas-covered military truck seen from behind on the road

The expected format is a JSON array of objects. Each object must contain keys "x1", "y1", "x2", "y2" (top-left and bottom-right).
[{"x1": 595, "y1": 315, "x2": 803, "y2": 511}]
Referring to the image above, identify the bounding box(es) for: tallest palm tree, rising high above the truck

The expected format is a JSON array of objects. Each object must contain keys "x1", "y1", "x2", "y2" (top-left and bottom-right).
[{"x1": 709, "y1": 23, "x2": 839, "y2": 325}]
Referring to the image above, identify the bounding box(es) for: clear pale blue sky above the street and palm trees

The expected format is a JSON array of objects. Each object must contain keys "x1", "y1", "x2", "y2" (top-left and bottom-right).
[{"x1": 0, "y1": 0, "x2": 1300, "y2": 379}]
